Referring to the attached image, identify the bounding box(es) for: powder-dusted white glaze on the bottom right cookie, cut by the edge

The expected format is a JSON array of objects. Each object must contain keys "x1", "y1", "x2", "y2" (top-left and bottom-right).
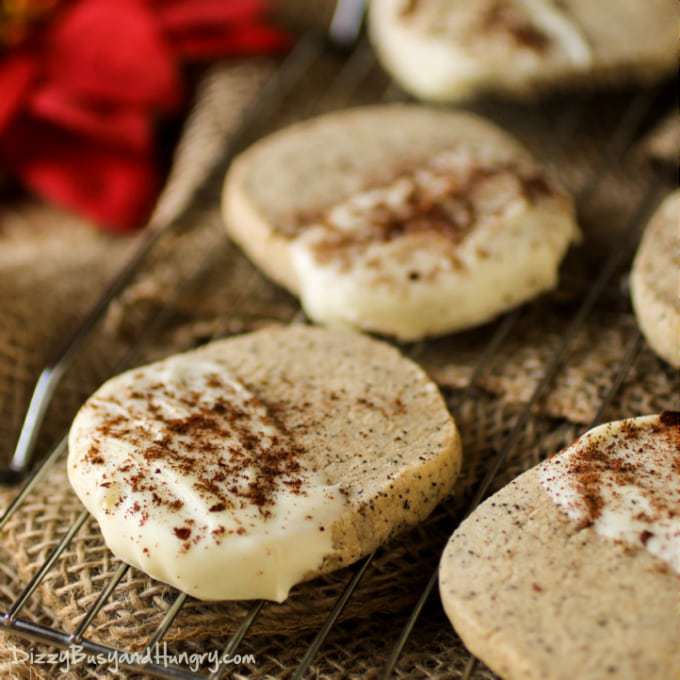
[{"x1": 540, "y1": 412, "x2": 680, "y2": 573}]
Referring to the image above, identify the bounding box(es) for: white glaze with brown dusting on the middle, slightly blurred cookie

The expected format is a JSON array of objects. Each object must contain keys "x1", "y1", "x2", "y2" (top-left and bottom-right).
[{"x1": 291, "y1": 145, "x2": 579, "y2": 340}]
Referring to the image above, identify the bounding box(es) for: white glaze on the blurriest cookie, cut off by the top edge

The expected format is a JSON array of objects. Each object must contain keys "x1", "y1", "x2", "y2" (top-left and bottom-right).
[{"x1": 369, "y1": 0, "x2": 594, "y2": 101}]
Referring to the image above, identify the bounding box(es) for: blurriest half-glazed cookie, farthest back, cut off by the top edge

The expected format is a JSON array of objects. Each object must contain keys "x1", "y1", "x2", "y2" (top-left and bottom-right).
[{"x1": 370, "y1": 0, "x2": 679, "y2": 101}]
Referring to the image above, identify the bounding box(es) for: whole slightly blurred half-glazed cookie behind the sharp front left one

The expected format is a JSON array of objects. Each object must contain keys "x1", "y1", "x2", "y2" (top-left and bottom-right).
[{"x1": 224, "y1": 105, "x2": 578, "y2": 340}]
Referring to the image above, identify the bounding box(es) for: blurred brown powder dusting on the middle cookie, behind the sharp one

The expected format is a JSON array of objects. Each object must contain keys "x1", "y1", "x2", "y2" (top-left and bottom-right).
[{"x1": 282, "y1": 147, "x2": 559, "y2": 270}]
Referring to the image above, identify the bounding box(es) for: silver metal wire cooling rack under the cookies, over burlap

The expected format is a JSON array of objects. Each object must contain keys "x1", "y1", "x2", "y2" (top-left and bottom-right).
[{"x1": 0, "y1": 9, "x2": 680, "y2": 680}]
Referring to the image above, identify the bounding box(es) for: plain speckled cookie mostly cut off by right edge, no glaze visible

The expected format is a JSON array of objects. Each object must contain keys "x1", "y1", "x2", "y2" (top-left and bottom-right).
[{"x1": 630, "y1": 189, "x2": 680, "y2": 368}]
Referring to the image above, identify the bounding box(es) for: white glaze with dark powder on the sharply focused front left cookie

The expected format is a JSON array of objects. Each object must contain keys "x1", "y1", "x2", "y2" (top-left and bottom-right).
[{"x1": 68, "y1": 356, "x2": 345, "y2": 602}]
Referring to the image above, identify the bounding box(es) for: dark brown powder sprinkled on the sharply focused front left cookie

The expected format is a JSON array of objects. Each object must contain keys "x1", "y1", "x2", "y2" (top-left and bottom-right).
[{"x1": 86, "y1": 374, "x2": 305, "y2": 549}]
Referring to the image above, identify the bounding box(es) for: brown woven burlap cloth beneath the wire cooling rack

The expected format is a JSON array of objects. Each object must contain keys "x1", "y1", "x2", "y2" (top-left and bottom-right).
[{"x1": 0, "y1": 3, "x2": 678, "y2": 678}]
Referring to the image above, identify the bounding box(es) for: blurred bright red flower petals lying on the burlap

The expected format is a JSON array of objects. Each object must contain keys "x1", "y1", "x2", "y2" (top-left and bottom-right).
[{"x1": 0, "y1": 0, "x2": 288, "y2": 230}]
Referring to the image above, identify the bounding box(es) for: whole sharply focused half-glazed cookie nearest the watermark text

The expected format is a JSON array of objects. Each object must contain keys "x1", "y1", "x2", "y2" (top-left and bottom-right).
[{"x1": 68, "y1": 326, "x2": 461, "y2": 601}]
